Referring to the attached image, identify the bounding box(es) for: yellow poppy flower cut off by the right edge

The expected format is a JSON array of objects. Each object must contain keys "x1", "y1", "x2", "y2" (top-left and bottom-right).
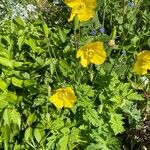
[{"x1": 134, "y1": 50, "x2": 150, "y2": 75}]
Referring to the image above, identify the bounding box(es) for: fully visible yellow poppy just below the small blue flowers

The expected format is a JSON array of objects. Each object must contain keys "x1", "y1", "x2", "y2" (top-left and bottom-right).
[{"x1": 76, "y1": 42, "x2": 106, "y2": 67}]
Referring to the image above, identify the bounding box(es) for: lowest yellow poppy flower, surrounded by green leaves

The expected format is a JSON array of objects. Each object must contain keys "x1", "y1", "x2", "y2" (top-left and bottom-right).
[{"x1": 49, "y1": 87, "x2": 76, "y2": 108}]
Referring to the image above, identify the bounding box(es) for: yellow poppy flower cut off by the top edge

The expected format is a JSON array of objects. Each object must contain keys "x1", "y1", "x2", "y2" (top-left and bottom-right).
[{"x1": 65, "y1": 0, "x2": 96, "y2": 22}]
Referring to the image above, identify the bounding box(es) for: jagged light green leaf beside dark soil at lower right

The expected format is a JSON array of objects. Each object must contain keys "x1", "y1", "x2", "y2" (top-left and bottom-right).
[{"x1": 109, "y1": 113, "x2": 125, "y2": 135}]
